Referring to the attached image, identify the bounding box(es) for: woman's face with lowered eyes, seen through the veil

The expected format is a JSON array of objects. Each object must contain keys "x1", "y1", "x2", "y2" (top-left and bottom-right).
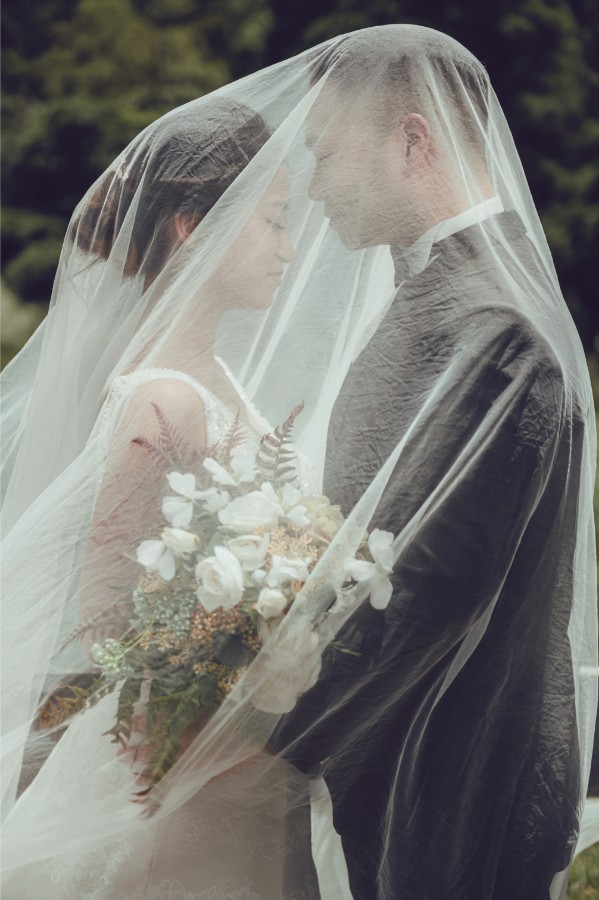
[{"x1": 218, "y1": 168, "x2": 293, "y2": 309}]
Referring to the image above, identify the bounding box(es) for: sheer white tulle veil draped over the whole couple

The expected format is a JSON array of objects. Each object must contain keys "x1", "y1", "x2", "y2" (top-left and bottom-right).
[{"x1": 2, "y1": 25, "x2": 597, "y2": 900}]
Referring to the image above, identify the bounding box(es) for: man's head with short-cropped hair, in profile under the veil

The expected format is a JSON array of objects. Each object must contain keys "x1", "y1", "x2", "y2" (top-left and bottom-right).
[{"x1": 306, "y1": 26, "x2": 491, "y2": 248}]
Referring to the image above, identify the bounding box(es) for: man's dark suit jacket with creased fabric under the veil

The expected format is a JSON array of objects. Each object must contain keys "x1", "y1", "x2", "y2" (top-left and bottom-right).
[{"x1": 274, "y1": 213, "x2": 582, "y2": 900}]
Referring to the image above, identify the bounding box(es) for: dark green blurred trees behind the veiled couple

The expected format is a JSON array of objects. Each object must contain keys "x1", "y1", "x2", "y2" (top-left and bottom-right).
[{"x1": 2, "y1": 0, "x2": 599, "y2": 349}]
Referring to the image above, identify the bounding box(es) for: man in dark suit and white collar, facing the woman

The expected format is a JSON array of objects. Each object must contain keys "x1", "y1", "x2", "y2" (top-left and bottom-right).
[{"x1": 273, "y1": 29, "x2": 584, "y2": 900}]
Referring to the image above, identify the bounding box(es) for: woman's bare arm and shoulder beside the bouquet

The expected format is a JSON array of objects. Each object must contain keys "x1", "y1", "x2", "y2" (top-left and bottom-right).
[{"x1": 78, "y1": 378, "x2": 206, "y2": 660}]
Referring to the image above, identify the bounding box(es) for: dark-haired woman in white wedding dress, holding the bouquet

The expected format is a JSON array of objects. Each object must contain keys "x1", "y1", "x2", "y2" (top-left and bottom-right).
[{"x1": 0, "y1": 99, "x2": 328, "y2": 900}]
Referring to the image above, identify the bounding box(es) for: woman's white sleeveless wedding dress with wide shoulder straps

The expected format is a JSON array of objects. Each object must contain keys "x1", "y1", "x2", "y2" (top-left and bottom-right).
[{"x1": 3, "y1": 367, "x2": 351, "y2": 900}]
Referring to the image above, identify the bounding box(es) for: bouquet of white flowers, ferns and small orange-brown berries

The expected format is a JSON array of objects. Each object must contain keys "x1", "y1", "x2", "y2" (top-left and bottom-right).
[{"x1": 46, "y1": 405, "x2": 393, "y2": 794}]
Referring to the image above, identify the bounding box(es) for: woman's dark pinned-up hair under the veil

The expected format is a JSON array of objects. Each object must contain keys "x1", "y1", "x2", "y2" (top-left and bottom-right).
[{"x1": 69, "y1": 100, "x2": 271, "y2": 278}]
